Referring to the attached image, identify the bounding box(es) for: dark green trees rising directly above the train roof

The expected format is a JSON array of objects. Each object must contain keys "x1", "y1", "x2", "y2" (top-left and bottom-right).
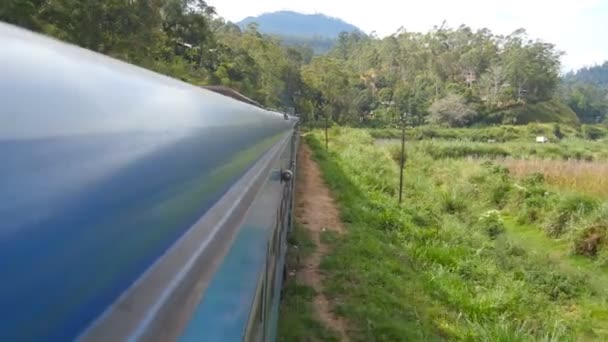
[{"x1": 0, "y1": 0, "x2": 312, "y2": 109}]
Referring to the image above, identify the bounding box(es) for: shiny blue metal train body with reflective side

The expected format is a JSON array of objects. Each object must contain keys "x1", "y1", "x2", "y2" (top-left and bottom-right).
[{"x1": 0, "y1": 23, "x2": 297, "y2": 341}]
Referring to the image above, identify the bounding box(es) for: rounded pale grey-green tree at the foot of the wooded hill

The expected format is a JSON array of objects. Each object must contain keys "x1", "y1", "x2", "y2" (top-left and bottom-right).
[{"x1": 429, "y1": 94, "x2": 477, "y2": 127}]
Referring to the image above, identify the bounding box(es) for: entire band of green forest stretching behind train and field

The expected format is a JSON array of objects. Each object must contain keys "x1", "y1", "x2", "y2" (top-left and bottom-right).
[{"x1": 0, "y1": 0, "x2": 608, "y2": 127}]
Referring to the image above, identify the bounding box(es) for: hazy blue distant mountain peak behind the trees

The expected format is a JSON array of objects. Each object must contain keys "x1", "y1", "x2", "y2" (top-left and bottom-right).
[{"x1": 237, "y1": 11, "x2": 361, "y2": 53}]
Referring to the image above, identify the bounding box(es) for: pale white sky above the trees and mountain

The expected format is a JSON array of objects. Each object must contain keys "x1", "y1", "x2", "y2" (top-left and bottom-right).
[{"x1": 207, "y1": 0, "x2": 608, "y2": 71}]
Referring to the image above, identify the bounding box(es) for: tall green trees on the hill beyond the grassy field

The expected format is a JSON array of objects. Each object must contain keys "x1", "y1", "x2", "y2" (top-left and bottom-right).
[{"x1": 313, "y1": 26, "x2": 561, "y2": 126}]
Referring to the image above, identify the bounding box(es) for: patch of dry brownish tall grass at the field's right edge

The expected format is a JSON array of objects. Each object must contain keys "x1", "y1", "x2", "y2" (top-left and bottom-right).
[{"x1": 498, "y1": 158, "x2": 608, "y2": 198}]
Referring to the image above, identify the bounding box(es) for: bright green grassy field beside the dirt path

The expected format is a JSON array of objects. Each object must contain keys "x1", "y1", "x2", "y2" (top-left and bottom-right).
[{"x1": 283, "y1": 128, "x2": 608, "y2": 341}]
